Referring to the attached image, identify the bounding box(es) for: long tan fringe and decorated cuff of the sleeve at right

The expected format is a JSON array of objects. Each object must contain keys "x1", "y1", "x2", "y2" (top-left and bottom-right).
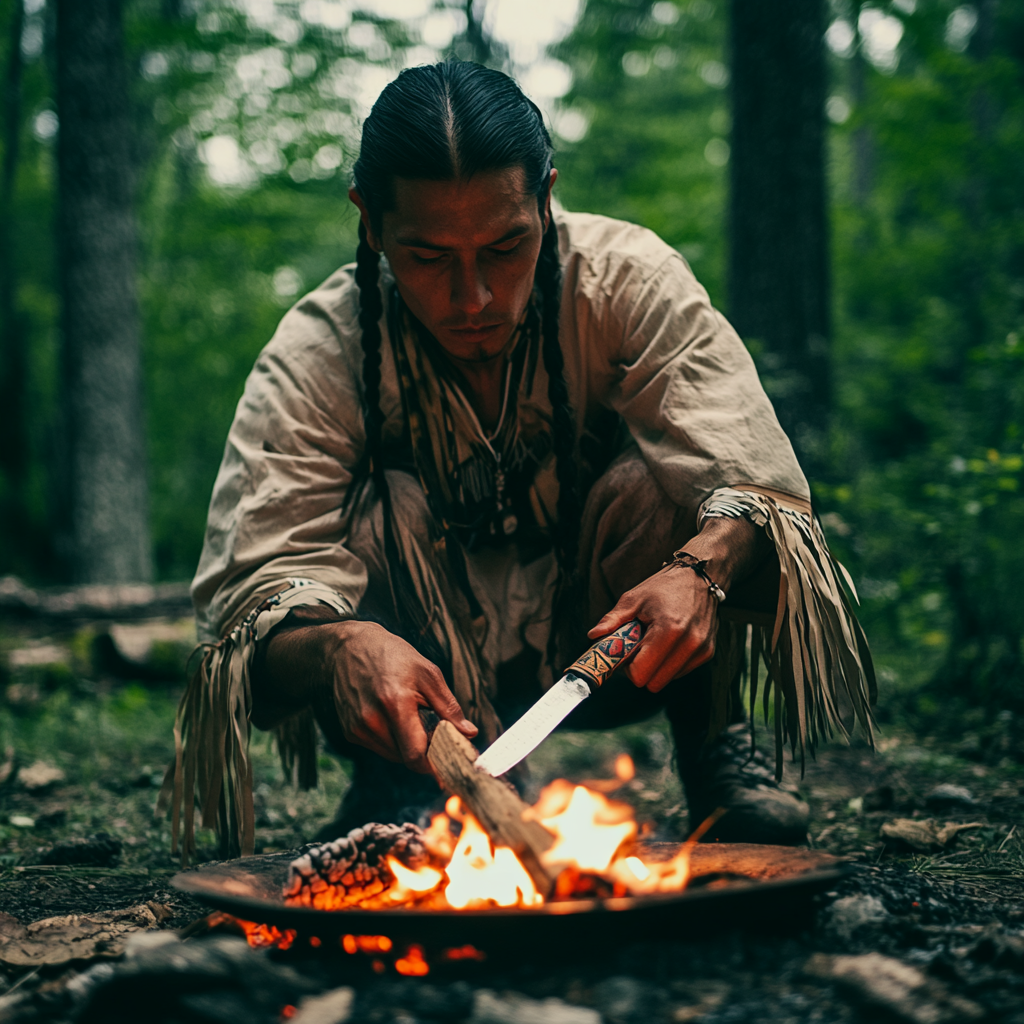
[{"x1": 697, "y1": 484, "x2": 878, "y2": 778}]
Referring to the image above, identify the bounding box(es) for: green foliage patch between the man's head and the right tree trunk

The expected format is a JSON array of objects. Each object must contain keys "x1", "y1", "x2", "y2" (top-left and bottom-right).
[{"x1": 555, "y1": 0, "x2": 729, "y2": 304}]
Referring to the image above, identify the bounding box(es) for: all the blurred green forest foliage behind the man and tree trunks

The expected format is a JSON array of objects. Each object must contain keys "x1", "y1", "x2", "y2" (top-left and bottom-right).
[{"x1": 0, "y1": 0, "x2": 1024, "y2": 728}]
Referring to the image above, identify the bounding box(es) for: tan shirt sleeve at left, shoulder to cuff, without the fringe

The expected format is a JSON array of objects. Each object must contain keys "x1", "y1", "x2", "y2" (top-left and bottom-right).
[{"x1": 191, "y1": 272, "x2": 367, "y2": 641}]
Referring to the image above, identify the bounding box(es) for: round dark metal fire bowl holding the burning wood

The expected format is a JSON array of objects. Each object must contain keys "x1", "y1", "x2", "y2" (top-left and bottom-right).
[{"x1": 171, "y1": 843, "x2": 853, "y2": 950}]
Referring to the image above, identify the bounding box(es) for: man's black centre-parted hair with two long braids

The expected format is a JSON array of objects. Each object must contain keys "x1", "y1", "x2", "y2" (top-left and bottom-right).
[{"x1": 353, "y1": 60, "x2": 580, "y2": 577}]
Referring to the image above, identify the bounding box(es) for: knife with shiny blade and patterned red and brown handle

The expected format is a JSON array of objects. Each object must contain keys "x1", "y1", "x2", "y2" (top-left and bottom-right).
[{"x1": 473, "y1": 618, "x2": 643, "y2": 776}]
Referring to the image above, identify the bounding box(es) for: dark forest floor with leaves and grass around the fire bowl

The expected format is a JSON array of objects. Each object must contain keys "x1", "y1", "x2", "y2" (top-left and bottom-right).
[{"x1": 0, "y1": 610, "x2": 1024, "y2": 1024}]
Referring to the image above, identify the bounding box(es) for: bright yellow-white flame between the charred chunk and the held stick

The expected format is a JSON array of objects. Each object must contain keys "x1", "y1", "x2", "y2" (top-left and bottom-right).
[{"x1": 444, "y1": 814, "x2": 544, "y2": 910}]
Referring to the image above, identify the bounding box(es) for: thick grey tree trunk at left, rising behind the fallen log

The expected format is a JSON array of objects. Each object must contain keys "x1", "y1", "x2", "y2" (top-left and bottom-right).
[{"x1": 56, "y1": 0, "x2": 152, "y2": 583}]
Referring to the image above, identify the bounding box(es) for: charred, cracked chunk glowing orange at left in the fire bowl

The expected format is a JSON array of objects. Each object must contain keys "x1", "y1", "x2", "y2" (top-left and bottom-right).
[{"x1": 285, "y1": 821, "x2": 430, "y2": 910}]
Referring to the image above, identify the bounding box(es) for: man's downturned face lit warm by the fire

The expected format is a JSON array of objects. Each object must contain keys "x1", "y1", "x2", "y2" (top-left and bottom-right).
[{"x1": 349, "y1": 168, "x2": 556, "y2": 362}]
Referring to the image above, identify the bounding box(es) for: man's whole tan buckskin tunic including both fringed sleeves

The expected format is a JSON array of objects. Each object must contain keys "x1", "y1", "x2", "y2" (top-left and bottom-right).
[{"x1": 164, "y1": 212, "x2": 873, "y2": 855}]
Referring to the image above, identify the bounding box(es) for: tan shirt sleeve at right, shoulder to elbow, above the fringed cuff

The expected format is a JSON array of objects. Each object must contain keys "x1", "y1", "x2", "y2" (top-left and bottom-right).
[{"x1": 566, "y1": 218, "x2": 809, "y2": 516}]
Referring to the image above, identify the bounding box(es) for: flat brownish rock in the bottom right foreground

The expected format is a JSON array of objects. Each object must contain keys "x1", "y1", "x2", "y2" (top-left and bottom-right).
[{"x1": 804, "y1": 953, "x2": 985, "y2": 1024}]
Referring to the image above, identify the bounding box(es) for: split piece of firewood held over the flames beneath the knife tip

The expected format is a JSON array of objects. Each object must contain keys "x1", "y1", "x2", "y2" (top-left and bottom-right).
[{"x1": 427, "y1": 721, "x2": 556, "y2": 897}]
